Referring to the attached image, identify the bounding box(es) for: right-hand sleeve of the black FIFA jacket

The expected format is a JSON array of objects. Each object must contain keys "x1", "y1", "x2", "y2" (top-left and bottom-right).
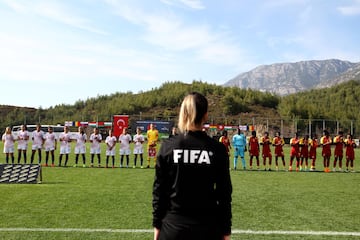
[{"x1": 216, "y1": 143, "x2": 232, "y2": 235}]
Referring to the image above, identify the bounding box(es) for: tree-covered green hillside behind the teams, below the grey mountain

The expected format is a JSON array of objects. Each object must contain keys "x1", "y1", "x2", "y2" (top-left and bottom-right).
[{"x1": 0, "y1": 81, "x2": 360, "y2": 134}]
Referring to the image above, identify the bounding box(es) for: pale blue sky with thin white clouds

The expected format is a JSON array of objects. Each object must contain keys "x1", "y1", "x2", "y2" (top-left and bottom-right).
[{"x1": 0, "y1": 0, "x2": 360, "y2": 108}]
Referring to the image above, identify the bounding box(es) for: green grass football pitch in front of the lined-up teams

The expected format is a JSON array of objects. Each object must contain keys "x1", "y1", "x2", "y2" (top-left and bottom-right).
[{"x1": 0, "y1": 144, "x2": 360, "y2": 240}]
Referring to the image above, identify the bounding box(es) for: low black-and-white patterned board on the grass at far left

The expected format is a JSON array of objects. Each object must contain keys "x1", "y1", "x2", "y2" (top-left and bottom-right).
[{"x1": 0, "y1": 164, "x2": 42, "y2": 183}]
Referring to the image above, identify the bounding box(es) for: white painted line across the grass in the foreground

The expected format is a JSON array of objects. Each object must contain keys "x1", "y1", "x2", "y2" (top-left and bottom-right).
[{"x1": 0, "y1": 228, "x2": 360, "y2": 236}]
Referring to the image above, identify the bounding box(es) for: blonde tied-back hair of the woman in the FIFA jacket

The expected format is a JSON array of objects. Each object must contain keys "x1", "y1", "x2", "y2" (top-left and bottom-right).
[{"x1": 178, "y1": 92, "x2": 208, "y2": 133}]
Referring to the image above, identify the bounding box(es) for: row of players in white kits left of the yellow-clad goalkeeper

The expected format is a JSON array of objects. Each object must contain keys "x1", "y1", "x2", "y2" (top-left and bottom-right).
[{"x1": 2, "y1": 125, "x2": 150, "y2": 168}]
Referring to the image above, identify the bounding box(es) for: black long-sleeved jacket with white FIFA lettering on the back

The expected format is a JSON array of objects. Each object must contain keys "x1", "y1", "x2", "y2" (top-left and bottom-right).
[{"x1": 153, "y1": 131, "x2": 232, "y2": 235}]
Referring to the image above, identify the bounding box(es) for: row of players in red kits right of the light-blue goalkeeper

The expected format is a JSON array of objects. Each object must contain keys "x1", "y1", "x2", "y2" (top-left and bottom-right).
[{"x1": 248, "y1": 130, "x2": 356, "y2": 172}]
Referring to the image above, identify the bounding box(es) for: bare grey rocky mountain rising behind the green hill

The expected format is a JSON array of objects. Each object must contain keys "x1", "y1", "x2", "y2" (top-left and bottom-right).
[{"x1": 224, "y1": 59, "x2": 360, "y2": 95}]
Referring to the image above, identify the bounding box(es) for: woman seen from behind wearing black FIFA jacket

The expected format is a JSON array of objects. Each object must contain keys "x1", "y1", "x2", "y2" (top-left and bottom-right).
[{"x1": 153, "y1": 93, "x2": 232, "y2": 240}]
